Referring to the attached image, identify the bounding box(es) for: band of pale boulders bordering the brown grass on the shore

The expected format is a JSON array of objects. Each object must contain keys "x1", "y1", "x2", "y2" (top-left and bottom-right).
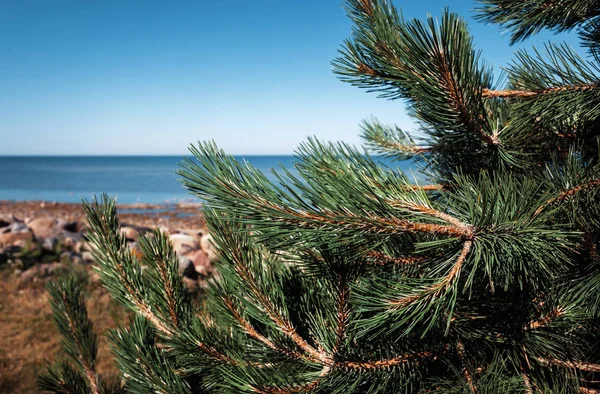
[{"x1": 0, "y1": 214, "x2": 215, "y2": 287}]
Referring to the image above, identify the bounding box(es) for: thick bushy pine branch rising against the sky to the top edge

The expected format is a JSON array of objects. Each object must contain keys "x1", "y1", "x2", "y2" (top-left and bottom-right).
[{"x1": 333, "y1": 4, "x2": 499, "y2": 151}]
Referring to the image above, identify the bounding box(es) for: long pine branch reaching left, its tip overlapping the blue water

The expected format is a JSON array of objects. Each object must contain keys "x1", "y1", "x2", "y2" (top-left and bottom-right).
[{"x1": 179, "y1": 144, "x2": 472, "y2": 242}]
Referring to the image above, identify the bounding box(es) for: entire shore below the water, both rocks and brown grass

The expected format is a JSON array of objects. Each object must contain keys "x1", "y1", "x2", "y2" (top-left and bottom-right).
[{"x1": 0, "y1": 201, "x2": 215, "y2": 393}]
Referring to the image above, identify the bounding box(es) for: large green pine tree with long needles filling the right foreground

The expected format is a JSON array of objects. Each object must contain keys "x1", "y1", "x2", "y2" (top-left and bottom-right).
[{"x1": 39, "y1": 0, "x2": 600, "y2": 394}]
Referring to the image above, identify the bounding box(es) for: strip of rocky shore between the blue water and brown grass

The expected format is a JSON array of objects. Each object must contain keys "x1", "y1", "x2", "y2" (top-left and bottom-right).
[{"x1": 0, "y1": 201, "x2": 213, "y2": 287}]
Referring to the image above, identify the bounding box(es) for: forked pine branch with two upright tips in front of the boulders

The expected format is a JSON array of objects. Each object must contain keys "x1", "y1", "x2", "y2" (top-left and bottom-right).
[{"x1": 84, "y1": 195, "x2": 235, "y2": 364}]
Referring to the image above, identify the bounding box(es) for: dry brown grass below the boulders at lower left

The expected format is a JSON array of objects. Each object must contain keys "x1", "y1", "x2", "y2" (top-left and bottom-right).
[{"x1": 0, "y1": 267, "x2": 126, "y2": 393}]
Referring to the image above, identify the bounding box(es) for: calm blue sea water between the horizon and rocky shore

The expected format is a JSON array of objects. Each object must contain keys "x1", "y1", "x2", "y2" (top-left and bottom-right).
[{"x1": 0, "y1": 156, "x2": 418, "y2": 203}]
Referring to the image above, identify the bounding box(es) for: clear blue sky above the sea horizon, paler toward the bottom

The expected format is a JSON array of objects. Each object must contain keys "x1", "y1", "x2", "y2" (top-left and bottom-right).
[{"x1": 0, "y1": 0, "x2": 577, "y2": 155}]
